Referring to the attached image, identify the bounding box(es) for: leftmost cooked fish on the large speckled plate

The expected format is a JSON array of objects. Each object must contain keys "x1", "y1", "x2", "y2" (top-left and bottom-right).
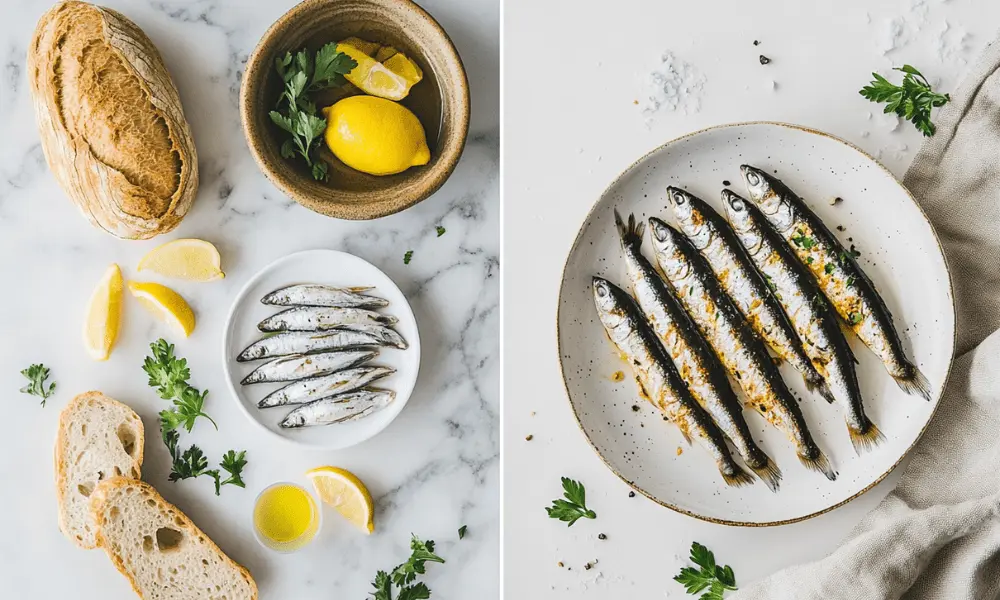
[{"x1": 593, "y1": 277, "x2": 753, "y2": 486}]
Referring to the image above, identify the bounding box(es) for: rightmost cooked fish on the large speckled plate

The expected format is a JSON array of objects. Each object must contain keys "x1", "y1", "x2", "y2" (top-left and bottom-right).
[{"x1": 740, "y1": 165, "x2": 931, "y2": 401}]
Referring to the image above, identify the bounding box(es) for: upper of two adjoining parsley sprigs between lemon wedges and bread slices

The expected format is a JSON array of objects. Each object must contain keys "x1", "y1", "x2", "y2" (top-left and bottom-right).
[{"x1": 142, "y1": 339, "x2": 219, "y2": 432}]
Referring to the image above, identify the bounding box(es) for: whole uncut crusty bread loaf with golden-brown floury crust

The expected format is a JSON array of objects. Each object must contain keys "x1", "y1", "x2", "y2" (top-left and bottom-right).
[{"x1": 28, "y1": 1, "x2": 198, "y2": 239}]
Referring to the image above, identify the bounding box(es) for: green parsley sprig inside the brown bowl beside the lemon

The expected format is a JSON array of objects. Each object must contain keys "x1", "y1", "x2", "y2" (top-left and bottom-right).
[{"x1": 270, "y1": 42, "x2": 358, "y2": 180}]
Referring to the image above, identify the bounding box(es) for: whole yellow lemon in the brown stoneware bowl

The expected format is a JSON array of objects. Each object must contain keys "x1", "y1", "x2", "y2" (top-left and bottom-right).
[{"x1": 323, "y1": 96, "x2": 431, "y2": 175}]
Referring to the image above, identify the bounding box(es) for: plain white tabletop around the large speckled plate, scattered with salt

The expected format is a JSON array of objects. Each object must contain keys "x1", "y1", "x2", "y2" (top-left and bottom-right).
[{"x1": 504, "y1": 0, "x2": 1000, "y2": 600}]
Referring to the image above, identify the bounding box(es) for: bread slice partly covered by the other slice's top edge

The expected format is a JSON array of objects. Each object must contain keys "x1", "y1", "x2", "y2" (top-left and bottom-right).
[{"x1": 55, "y1": 392, "x2": 144, "y2": 548}]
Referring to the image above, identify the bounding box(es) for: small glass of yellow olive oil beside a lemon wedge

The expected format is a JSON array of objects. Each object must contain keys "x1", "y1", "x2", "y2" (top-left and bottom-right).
[{"x1": 253, "y1": 482, "x2": 323, "y2": 552}]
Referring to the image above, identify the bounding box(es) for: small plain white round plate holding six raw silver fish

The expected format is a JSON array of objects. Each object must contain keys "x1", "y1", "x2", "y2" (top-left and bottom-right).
[{"x1": 222, "y1": 250, "x2": 420, "y2": 450}]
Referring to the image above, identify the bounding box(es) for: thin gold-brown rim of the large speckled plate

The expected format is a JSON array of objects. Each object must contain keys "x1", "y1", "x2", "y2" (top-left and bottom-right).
[{"x1": 556, "y1": 121, "x2": 958, "y2": 527}]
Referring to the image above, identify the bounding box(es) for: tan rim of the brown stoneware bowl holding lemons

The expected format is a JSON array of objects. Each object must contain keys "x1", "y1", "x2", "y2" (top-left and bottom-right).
[{"x1": 239, "y1": 0, "x2": 471, "y2": 220}]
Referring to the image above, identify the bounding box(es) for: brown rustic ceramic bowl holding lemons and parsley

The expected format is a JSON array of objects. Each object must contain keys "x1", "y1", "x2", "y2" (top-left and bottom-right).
[{"x1": 240, "y1": 0, "x2": 470, "y2": 220}]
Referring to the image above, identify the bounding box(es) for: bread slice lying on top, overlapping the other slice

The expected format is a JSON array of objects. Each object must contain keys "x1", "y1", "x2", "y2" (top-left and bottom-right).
[{"x1": 91, "y1": 477, "x2": 257, "y2": 600}]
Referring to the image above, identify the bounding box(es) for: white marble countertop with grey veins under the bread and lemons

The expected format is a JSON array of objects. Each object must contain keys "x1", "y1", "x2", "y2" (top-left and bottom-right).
[{"x1": 0, "y1": 0, "x2": 500, "y2": 600}]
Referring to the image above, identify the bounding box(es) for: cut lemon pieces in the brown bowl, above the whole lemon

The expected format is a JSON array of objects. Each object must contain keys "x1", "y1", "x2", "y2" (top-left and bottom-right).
[{"x1": 337, "y1": 38, "x2": 423, "y2": 101}]
